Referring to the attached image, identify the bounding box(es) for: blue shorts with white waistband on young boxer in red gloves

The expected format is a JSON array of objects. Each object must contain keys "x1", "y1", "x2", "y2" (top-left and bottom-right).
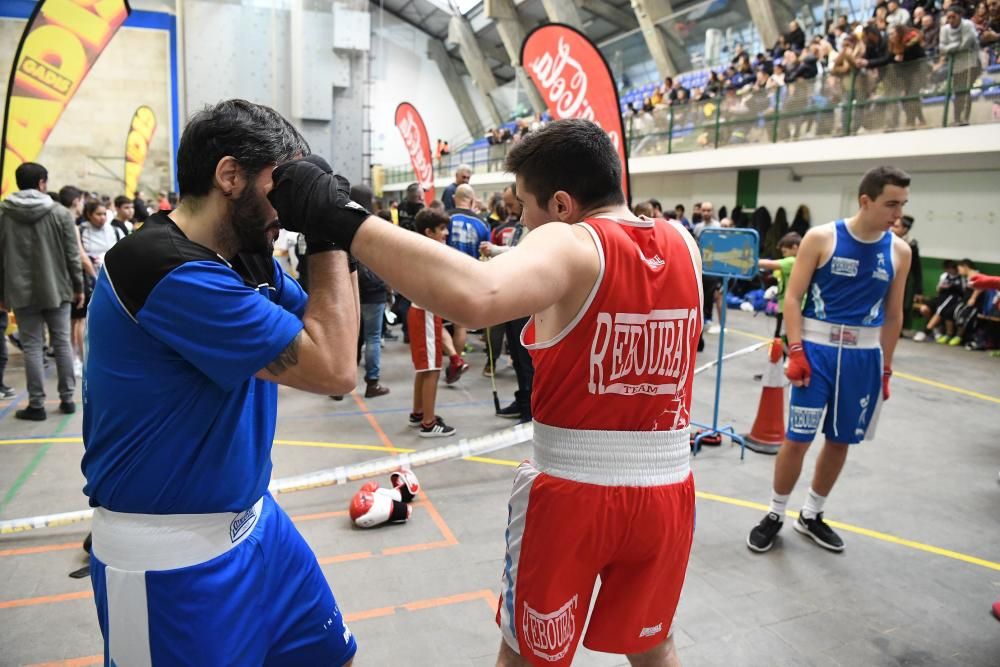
[{"x1": 785, "y1": 319, "x2": 882, "y2": 445}]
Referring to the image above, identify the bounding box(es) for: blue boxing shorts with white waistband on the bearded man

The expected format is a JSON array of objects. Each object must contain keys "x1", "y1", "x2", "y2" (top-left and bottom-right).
[{"x1": 90, "y1": 494, "x2": 357, "y2": 667}]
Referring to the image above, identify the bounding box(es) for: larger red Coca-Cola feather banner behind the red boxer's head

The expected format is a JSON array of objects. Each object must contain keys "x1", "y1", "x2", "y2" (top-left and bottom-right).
[{"x1": 520, "y1": 23, "x2": 629, "y2": 201}]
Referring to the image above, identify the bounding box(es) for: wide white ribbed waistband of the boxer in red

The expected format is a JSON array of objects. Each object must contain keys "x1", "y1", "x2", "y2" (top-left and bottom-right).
[{"x1": 534, "y1": 421, "x2": 691, "y2": 486}]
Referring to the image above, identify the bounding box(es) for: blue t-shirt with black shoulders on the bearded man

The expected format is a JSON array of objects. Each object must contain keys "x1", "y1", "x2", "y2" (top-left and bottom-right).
[{"x1": 82, "y1": 214, "x2": 307, "y2": 514}]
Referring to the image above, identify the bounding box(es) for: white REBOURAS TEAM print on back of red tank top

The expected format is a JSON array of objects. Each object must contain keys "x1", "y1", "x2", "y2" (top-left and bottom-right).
[{"x1": 587, "y1": 308, "x2": 698, "y2": 396}]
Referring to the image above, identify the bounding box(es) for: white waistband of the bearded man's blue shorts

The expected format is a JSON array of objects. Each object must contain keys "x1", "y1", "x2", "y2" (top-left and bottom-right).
[{"x1": 91, "y1": 497, "x2": 264, "y2": 572}]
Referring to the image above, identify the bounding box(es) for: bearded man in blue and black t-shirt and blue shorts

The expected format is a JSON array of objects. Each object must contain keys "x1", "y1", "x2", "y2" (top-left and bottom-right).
[{"x1": 82, "y1": 100, "x2": 358, "y2": 666}]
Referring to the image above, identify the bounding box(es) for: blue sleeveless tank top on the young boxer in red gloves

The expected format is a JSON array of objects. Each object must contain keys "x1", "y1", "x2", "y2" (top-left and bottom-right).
[{"x1": 802, "y1": 220, "x2": 896, "y2": 327}]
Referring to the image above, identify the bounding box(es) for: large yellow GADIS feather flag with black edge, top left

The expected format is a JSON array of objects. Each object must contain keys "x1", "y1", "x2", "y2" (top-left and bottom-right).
[{"x1": 0, "y1": 0, "x2": 132, "y2": 198}]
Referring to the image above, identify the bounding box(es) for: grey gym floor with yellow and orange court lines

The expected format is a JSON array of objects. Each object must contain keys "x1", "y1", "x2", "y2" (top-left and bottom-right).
[{"x1": 0, "y1": 312, "x2": 1000, "y2": 667}]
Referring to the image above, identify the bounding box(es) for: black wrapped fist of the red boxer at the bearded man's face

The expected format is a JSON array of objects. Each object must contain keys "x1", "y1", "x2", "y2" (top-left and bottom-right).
[{"x1": 267, "y1": 155, "x2": 371, "y2": 250}]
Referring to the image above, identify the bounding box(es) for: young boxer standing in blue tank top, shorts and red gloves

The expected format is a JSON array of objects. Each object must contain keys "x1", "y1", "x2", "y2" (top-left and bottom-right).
[{"x1": 747, "y1": 167, "x2": 911, "y2": 552}]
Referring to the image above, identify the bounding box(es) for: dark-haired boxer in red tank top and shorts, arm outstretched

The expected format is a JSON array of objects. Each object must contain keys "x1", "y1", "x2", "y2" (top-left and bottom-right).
[{"x1": 278, "y1": 120, "x2": 702, "y2": 667}]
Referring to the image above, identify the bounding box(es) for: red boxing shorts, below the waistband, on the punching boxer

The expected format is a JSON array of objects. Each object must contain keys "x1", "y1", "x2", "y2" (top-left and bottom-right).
[{"x1": 497, "y1": 461, "x2": 695, "y2": 666}]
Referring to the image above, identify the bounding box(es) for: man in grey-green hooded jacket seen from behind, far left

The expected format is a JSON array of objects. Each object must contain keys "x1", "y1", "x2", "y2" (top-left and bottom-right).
[{"x1": 0, "y1": 162, "x2": 83, "y2": 421}]
